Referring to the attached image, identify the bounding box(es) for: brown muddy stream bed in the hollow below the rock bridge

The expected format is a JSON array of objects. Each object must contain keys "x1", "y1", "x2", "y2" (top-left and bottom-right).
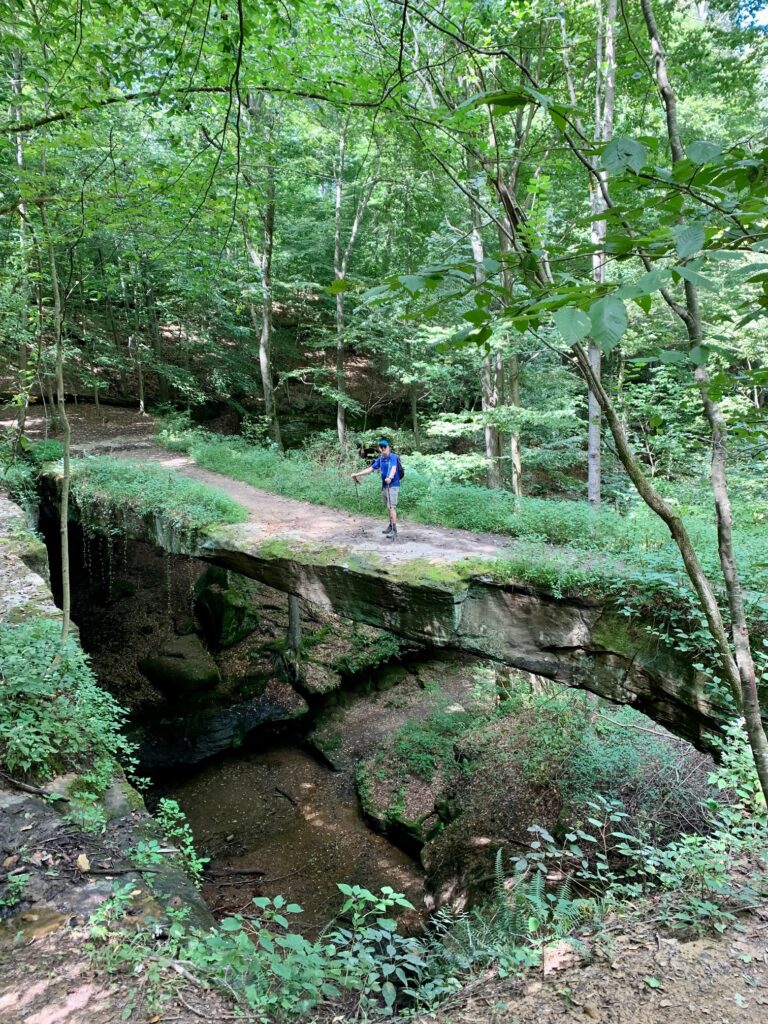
[{"x1": 154, "y1": 744, "x2": 424, "y2": 934}]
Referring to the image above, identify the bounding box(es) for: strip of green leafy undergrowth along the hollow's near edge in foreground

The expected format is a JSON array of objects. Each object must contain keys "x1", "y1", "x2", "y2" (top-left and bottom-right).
[{"x1": 90, "y1": 726, "x2": 768, "y2": 1022}]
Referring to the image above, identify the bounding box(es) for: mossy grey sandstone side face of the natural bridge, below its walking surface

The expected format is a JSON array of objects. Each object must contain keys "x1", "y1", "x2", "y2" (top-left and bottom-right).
[{"x1": 205, "y1": 527, "x2": 728, "y2": 751}]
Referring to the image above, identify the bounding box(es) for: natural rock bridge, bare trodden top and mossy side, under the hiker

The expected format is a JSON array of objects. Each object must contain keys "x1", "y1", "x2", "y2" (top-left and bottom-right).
[{"x1": 36, "y1": 445, "x2": 741, "y2": 750}]
